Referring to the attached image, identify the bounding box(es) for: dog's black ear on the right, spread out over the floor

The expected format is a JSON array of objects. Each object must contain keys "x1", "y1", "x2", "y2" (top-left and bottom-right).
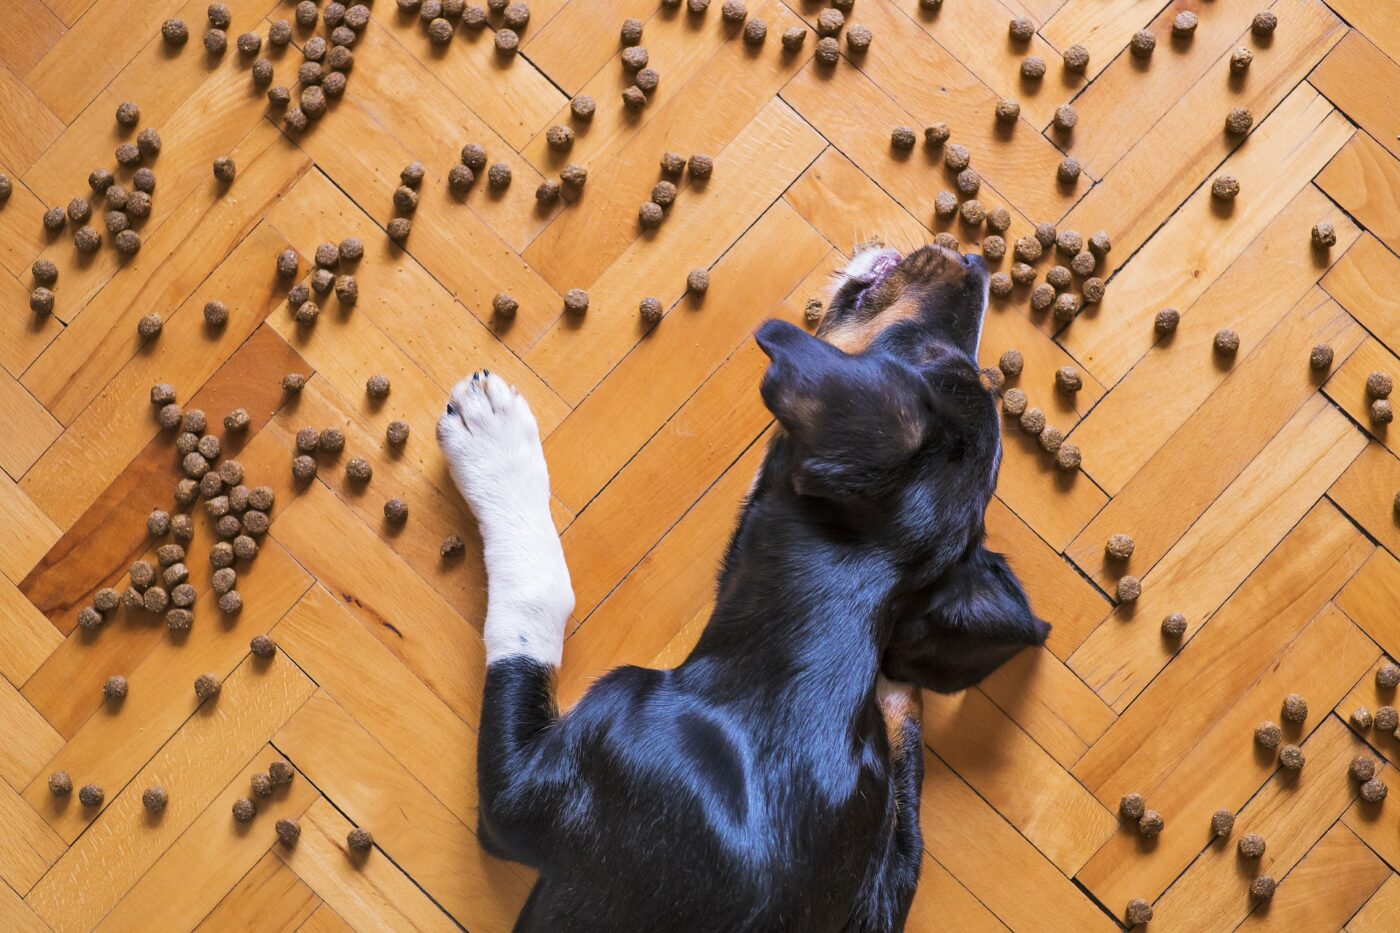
[{"x1": 882, "y1": 545, "x2": 1050, "y2": 693}]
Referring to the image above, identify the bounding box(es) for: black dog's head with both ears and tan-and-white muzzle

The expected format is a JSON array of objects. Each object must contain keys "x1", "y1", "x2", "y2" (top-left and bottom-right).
[{"x1": 757, "y1": 247, "x2": 1049, "y2": 692}]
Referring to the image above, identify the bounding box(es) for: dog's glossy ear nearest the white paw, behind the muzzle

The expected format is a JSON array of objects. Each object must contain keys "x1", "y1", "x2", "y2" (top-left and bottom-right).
[{"x1": 755, "y1": 321, "x2": 931, "y2": 499}]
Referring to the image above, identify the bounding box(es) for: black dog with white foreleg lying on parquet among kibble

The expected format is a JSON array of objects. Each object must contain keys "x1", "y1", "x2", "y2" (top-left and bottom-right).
[{"x1": 437, "y1": 245, "x2": 1049, "y2": 933}]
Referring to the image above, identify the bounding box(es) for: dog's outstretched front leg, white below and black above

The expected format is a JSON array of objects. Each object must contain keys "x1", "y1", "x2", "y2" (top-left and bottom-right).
[{"x1": 437, "y1": 371, "x2": 574, "y2": 867}]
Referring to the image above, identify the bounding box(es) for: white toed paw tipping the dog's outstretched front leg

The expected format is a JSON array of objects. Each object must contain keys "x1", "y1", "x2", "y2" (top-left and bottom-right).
[{"x1": 437, "y1": 370, "x2": 549, "y2": 534}]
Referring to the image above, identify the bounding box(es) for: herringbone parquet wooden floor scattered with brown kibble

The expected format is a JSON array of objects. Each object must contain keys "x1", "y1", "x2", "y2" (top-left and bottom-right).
[{"x1": 0, "y1": 0, "x2": 1400, "y2": 933}]
